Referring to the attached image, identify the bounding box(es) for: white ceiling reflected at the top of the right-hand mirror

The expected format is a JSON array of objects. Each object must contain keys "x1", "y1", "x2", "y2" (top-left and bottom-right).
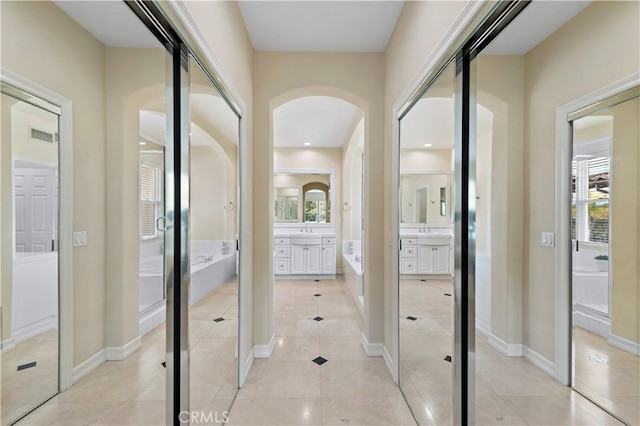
[{"x1": 482, "y1": 0, "x2": 591, "y2": 55}]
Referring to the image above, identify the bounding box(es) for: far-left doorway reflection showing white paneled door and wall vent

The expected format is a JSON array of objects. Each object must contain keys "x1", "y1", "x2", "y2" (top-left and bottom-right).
[{"x1": 0, "y1": 93, "x2": 59, "y2": 424}]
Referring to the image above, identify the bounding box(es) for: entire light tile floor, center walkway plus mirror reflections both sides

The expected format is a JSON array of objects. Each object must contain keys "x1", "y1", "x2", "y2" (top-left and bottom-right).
[{"x1": 10, "y1": 278, "x2": 632, "y2": 425}]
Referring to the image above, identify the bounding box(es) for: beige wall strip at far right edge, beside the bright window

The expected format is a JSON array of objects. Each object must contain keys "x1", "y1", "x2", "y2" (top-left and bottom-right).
[{"x1": 609, "y1": 98, "x2": 640, "y2": 343}]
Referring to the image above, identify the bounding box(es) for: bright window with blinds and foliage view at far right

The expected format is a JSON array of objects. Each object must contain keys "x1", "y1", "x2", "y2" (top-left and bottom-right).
[{"x1": 571, "y1": 155, "x2": 611, "y2": 244}]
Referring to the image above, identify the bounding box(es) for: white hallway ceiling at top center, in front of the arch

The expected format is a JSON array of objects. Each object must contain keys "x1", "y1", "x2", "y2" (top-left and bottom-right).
[{"x1": 238, "y1": 0, "x2": 404, "y2": 52}]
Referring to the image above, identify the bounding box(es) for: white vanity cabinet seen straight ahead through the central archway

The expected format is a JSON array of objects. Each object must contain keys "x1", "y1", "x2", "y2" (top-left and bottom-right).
[{"x1": 273, "y1": 235, "x2": 336, "y2": 276}]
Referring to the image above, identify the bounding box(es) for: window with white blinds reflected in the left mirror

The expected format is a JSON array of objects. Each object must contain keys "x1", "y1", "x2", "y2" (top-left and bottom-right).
[{"x1": 140, "y1": 163, "x2": 162, "y2": 238}]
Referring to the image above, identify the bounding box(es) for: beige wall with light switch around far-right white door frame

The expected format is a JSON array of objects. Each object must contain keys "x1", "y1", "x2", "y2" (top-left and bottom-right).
[{"x1": 523, "y1": 2, "x2": 640, "y2": 360}]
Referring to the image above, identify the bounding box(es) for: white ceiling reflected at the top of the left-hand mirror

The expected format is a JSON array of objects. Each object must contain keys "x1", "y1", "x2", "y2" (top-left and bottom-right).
[{"x1": 54, "y1": 0, "x2": 162, "y2": 48}]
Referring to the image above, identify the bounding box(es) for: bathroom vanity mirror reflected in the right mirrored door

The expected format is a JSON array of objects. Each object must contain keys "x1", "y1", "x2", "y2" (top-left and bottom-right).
[{"x1": 400, "y1": 172, "x2": 451, "y2": 226}]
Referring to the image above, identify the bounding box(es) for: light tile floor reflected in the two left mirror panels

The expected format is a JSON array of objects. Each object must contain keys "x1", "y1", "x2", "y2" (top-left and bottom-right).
[{"x1": 15, "y1": 281, "x2": 238, "y2": 426}]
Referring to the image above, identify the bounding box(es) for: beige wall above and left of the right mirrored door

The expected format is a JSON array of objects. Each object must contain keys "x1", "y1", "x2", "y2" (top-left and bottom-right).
[{"x1": 380, "y1": 1, "x2": 467, "y2": 352}]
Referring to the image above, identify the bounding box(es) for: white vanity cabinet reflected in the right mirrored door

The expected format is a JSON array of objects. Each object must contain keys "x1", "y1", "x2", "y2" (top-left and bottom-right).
[{"x1": 400, "y1": 236, "x2": 451, "y2": 275}]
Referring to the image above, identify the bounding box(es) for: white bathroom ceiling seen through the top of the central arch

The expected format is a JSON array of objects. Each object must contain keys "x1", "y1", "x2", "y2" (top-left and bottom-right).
[{"x1": 273, "y1": 96, "x2": 362, "y2": 148}]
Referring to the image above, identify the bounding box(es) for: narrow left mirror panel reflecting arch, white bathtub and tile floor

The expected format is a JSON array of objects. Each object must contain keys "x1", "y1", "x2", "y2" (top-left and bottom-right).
[{"x1": 188, "y1": 58, "x2": 239, "y2": 418}]
